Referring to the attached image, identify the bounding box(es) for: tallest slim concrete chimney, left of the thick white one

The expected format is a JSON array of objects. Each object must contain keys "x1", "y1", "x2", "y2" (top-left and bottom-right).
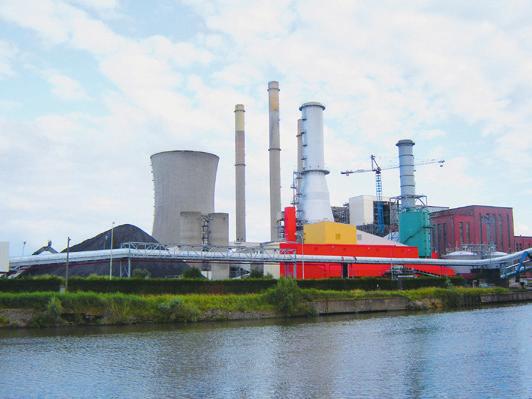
[{"x1": 268, "y1": 81, "x2": 281, "y2": 241}]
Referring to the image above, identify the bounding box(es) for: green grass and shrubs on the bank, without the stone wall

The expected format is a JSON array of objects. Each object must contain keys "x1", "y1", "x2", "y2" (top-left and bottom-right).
[{"x1": 0, "y1": 288, "x2": 509, "y2": 326}]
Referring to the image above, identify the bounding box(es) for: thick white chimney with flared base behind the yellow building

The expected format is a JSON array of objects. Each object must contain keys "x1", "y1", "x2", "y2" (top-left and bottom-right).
[{"x1": 299, "y1": 102, "x2": 334, "y2": 223}]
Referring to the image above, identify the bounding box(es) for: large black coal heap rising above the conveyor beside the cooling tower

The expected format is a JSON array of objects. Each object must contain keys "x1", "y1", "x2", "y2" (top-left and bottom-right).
[{"x1": 62, "y1": 224, "x2": 158, "y2": 252}]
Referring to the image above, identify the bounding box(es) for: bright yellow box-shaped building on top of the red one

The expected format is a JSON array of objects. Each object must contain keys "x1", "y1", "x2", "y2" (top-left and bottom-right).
[{"x1": 303, "y1": 222, "x2": 357, "y2": 244}]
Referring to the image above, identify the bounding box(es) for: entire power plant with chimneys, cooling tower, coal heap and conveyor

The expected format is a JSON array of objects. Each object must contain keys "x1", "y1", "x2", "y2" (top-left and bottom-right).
[{"x1": 0, "y1": 81, "x2": 532, "y2": 279}]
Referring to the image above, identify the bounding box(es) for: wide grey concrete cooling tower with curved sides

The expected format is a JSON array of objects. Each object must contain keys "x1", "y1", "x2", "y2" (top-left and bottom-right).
[{"x1": 151, "y1": 151, "x2": 219, "y2": 245}]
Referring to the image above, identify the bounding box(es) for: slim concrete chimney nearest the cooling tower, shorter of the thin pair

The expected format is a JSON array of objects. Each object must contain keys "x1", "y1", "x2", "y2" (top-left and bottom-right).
[{"x1": 235, "y1": 104, "x2": 246, "y2": 242}]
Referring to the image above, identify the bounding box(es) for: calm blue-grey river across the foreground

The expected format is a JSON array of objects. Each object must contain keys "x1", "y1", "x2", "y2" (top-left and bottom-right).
[{"x1": 0, "y1": 304, "x2": 532, "y2": 398}]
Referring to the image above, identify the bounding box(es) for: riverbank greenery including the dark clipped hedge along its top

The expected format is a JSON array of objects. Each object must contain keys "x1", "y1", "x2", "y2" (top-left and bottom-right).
[{"x1": 0, "y1": 278, "x2": 532, "y2": 328}]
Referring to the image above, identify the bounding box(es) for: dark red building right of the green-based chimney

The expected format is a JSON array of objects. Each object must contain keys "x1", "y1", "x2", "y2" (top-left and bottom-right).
[{"x1": 430, "y1": 205, "x2": 515, "y2": 255}]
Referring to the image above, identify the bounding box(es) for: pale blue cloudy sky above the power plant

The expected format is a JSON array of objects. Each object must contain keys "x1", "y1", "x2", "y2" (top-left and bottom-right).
[{"x1": 0, "y1": 0, "x2": 532, "y2": 256}]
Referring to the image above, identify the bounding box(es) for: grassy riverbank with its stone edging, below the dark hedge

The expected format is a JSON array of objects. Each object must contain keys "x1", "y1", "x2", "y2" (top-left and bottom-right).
[{"x1": 0, "y1": 281, "x2": 532, "y2": 328}]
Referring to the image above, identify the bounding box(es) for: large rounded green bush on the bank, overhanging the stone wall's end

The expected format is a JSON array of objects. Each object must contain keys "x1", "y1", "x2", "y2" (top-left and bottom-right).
[{"x1": 265, "y1": 278, "x2": 309, "y2": 316}]
